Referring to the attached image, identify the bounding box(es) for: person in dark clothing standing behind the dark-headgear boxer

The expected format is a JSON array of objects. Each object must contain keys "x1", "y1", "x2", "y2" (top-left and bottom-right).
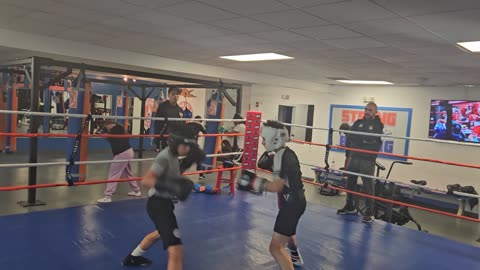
[{"x1": 154, "y1": 87, "x2": 185, "y2": 152}]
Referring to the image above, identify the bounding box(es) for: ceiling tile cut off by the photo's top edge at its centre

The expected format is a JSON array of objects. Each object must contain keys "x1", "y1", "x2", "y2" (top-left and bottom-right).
[{"x1": 198, "y1": 0, "x2": 292, "y2": 15}]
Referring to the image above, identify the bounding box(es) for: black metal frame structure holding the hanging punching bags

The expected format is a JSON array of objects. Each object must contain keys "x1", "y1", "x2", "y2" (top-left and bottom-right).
[{"x1": 0, "y1": 56, "x2": 242, "y2": 207}]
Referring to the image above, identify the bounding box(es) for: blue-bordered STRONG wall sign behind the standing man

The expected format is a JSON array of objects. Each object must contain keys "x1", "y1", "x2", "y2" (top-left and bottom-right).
[{"x1": 329, "y1": 105, "x2": 412, "y2": 160}]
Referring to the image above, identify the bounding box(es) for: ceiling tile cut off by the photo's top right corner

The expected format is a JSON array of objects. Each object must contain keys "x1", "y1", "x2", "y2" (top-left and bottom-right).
[{"x1": 374, "y1": 0, "x2": 480, "y2": 17}]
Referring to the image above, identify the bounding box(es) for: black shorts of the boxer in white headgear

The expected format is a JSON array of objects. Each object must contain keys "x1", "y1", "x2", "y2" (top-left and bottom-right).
[{"x1": 273, "y1": 195, "x2": 307, "y2": 237}]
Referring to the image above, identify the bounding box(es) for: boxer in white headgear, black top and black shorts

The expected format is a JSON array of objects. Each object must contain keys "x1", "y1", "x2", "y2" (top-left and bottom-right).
[{"x1": 238, "y1": 120, "x2": 307, "y2": 270}]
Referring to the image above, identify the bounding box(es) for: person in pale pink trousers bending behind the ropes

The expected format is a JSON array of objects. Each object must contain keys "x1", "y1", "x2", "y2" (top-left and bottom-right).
[{"x1": 96, "y1": 120, "x2": 142, "y2": 203}]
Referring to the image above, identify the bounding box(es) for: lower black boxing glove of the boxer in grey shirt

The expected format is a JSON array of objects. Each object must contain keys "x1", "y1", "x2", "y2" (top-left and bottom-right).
[{"x1": 155, "y1": 176, "x2": 194, "y2": 201}]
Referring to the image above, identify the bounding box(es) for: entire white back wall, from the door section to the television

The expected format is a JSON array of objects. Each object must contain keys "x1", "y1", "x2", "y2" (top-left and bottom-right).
[{"x1": 250, "y1": 85, "x2": 480, "y2": 193}]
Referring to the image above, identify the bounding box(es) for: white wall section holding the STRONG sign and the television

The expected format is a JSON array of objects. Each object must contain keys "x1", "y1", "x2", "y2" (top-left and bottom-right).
[{"x1": 324, "y1": 86, "x2": 480, "y2": 190}]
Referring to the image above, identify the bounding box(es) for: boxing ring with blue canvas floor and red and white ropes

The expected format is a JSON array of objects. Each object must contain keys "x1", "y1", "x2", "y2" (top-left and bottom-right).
[{"x1": 0, "y1": 110, "x2": 480, "y2": 270}]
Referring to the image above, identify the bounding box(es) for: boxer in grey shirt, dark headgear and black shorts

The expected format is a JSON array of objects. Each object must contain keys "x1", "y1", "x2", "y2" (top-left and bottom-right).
[{"x1": 122, "y1": 125, "x2": 205, "y2": 270}]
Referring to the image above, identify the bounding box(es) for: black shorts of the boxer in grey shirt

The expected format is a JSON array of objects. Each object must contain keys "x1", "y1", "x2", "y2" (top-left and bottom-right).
[{"x1": 147, "y1": 196, "x2": 182, "y2": 250}]
